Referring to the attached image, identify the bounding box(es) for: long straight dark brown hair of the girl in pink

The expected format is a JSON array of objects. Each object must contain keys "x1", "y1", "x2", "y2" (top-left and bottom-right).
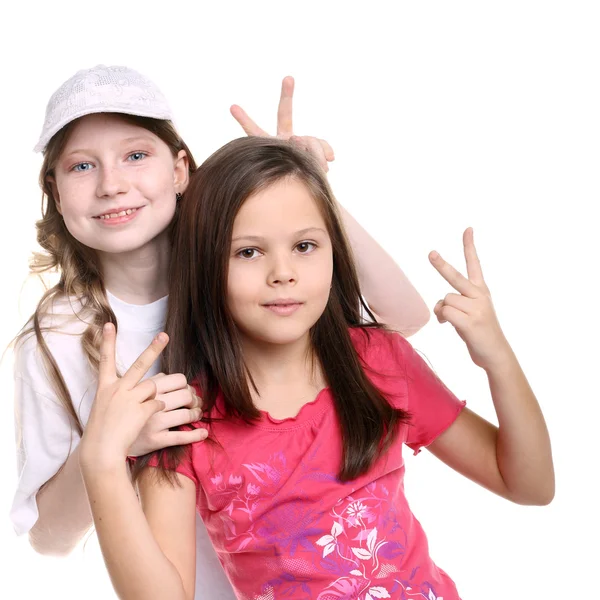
[{"x1": 143, "y1": 138, "x2": 408, "y2": 481}]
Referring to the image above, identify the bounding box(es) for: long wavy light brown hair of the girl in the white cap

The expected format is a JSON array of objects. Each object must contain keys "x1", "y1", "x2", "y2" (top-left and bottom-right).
[{"x1": 16, "y1": 114, "x2": 196, "y2": 435}]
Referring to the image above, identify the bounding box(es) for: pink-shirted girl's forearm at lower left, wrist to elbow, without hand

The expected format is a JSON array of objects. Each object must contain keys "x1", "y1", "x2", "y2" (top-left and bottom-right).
[{"x1": 82, "y1": 461, "x2": 188, "y2": 600}]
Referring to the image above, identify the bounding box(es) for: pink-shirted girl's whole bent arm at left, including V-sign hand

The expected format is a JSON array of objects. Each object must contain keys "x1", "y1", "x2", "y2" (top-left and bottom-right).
[{"x1": 79, "y1": 324, "x2": 196, "y2": 600}]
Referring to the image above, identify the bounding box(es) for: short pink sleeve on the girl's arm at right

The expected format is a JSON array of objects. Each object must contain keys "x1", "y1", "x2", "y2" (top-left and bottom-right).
[{"x1": 394, "y1": 335, "x2": 466, "y2": 454}]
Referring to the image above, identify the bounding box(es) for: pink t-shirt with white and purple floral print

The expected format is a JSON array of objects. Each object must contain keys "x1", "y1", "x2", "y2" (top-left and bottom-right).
[{"x1": 177, "y1": 329, "x2": 465, "y2": 600}]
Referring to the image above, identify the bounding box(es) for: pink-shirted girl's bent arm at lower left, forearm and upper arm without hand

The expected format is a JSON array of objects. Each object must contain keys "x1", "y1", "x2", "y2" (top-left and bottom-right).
[{"x1": 81, "y1": 456, "x2": 196, "y2": 600}]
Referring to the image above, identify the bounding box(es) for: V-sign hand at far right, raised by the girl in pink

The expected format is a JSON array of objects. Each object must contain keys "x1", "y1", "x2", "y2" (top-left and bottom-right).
[{"x1": 429, "y1": 227, "x2": 512, "y2": 370}]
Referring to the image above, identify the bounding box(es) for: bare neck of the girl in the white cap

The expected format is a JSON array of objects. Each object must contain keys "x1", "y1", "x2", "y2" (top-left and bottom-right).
[{"x1": 98, "y1": 232, "x2": 171, "y2": 304}]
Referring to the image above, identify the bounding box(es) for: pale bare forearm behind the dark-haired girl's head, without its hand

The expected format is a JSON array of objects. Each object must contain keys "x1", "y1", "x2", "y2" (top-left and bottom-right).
[{"x1": 338, "y1": 204, "x2": 429, "y2": 337}]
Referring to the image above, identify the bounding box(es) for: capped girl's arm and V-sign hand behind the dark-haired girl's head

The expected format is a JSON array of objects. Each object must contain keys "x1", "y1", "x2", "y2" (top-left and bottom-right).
[{"x1": 231, "y1": 77, "x2": 429, "y2": 337}]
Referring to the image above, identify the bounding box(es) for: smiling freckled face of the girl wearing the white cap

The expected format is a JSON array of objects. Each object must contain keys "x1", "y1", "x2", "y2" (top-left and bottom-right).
[{"x1": 51, "y1": 113, "x2": 188, "y2": 254}]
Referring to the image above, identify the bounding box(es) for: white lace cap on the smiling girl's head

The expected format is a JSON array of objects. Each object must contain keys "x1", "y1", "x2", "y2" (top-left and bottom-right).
[{"x1": 33, "y1": 65, "x2": 173, "y2": 152}]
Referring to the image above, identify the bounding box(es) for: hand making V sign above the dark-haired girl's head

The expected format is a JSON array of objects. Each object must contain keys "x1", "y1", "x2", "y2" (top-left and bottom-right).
[{"x1": 231, "y1": 77, "x2": 335, "y2": 172}]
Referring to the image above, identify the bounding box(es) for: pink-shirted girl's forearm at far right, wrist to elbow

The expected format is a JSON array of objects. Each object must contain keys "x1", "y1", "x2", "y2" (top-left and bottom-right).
[{"x1": 486, "y1": 349, "x2": 554, "y2": 504}]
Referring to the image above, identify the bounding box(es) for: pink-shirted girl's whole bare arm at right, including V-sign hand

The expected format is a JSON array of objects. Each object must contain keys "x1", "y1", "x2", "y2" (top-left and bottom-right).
[{"x1": 429, "y1": 230, "x2": 554, "y2": 504}]
